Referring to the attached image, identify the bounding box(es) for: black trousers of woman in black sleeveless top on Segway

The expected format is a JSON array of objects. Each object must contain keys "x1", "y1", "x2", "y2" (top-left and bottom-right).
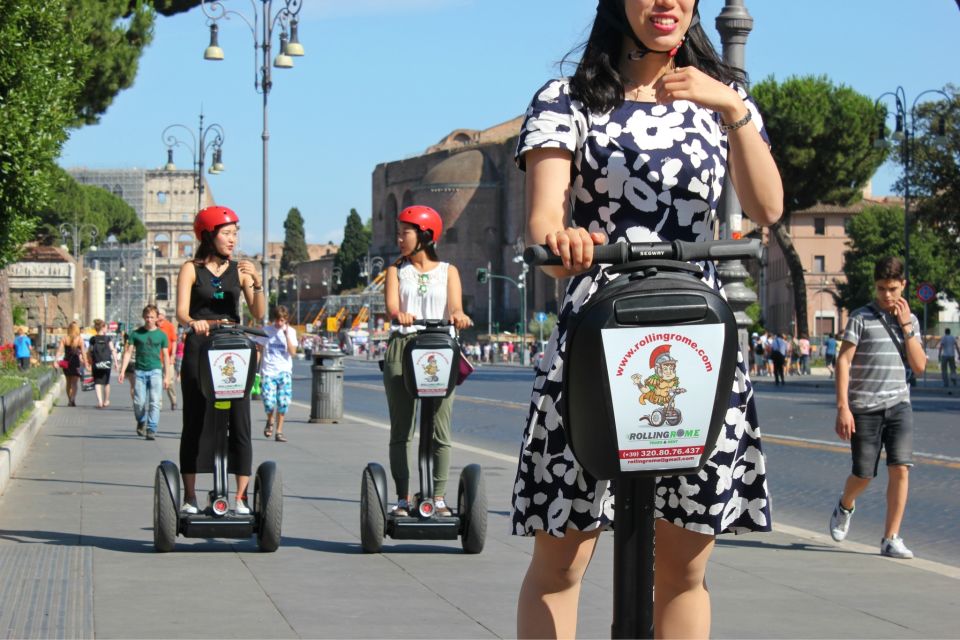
[{"x1": 180, "y1": 334, "x2": 253, "y2": 476}]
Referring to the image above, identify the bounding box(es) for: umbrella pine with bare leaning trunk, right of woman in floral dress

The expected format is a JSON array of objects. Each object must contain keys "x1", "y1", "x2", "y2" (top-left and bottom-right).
[{"x1": 747, "y1": 76, "x2": 886, "y2": 337}]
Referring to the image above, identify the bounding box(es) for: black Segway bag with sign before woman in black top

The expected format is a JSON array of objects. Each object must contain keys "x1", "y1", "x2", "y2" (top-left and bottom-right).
[{"x1": 200, "y1": 331, "x2": 257, "y2": 408}]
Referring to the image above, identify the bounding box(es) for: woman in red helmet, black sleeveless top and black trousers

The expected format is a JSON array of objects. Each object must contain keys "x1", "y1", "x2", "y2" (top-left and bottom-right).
[{"x1": 177, "y1": 206, "x2": 266, "y2": 515}]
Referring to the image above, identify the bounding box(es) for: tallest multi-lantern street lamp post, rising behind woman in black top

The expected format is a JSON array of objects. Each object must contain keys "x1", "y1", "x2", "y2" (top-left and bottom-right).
[{"x1": 200, "y1": 0, "x2": 304, "y2": 321}]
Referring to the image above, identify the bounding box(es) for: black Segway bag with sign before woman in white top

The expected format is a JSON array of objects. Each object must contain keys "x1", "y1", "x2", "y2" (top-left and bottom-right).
[{"x1": 403, "y1": 327, "x2": 460, "y2": 398}]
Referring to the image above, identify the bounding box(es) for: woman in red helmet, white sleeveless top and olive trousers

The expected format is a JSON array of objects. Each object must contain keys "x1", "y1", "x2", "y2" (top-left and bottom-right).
[{"x1": 383, "y1": 205, "x2": 473, "y2": 516}]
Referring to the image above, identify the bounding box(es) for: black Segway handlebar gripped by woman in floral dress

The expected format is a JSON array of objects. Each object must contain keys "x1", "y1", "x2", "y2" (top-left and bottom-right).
[{"x1": 523, "y1": 239, "x2": 762, "y2": 266}]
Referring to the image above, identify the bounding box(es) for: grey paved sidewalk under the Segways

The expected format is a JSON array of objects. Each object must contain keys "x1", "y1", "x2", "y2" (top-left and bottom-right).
[{"x1": 0, "y1": 378, "x2": 960, "y2": 638}]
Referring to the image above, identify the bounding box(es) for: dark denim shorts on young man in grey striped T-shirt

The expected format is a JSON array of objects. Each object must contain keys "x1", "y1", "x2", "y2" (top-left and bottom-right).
[{"x1": 850, "y1": 402, "x2": 913, "y2": 478}]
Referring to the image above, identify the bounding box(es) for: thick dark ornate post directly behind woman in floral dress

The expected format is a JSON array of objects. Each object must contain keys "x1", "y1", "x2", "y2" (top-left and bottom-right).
[{"x1": 716, "y1": 0, "x2": 757, "y2": 361}]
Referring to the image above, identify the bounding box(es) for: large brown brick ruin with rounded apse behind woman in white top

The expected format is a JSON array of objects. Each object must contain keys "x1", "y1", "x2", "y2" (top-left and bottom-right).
[{"x1": 370, "y1": 117, "x2": 563, "y2": 331}]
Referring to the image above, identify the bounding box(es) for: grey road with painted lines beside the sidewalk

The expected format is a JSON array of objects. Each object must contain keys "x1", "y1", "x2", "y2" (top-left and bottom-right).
[{"x1": 316, "y1": 359, "x2": 960, "y2": 566}]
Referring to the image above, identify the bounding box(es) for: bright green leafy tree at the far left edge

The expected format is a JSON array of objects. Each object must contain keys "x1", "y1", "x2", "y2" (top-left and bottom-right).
[{"x1": 0, "y1": 0, "x2": 91, "y2": 343}]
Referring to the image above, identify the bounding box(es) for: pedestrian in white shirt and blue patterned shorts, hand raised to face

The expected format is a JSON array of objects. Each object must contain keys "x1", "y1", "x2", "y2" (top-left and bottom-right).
[{"x1": 257, "y1": 305, "x2": 297, "y2": 442}]
